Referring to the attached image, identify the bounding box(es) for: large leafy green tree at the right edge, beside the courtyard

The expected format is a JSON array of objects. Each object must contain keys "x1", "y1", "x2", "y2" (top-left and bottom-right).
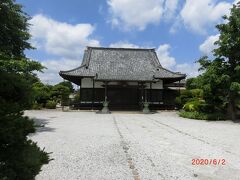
[{"x1": 198, "y1": 3, "x2": 240, "y2": 120}]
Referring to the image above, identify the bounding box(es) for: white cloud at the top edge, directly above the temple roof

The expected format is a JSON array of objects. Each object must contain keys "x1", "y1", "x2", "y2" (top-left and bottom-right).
[{"x1": 107, "y1": 0, "x2": 178, "y2": 30}]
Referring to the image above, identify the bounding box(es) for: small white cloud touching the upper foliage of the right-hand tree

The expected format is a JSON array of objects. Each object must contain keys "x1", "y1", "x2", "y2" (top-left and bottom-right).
[{"x1": 199, "y1": 34, "x2": 219, "y2": 55}]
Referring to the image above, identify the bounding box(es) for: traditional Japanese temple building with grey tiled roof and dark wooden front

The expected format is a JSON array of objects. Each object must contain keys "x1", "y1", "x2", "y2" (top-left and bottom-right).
[{"x1": 59, "y1": 47, "x2": 186, "y2": 110}]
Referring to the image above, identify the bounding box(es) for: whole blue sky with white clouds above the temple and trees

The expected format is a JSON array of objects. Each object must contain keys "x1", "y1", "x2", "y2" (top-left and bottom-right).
[{"x1": 17, "y1": 0, "x2": 237, "y2": 84}]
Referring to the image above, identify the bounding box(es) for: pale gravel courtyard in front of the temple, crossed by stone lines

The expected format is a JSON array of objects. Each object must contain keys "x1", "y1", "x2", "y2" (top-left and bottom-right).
[{"x1": 25, "y1": 111, "x2": 240, "y2": 180}]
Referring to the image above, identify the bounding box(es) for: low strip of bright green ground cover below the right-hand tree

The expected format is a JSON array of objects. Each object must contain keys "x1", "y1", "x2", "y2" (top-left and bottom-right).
[{"x1": 179, "y1": 111, "x2": 226, "y2": 121}]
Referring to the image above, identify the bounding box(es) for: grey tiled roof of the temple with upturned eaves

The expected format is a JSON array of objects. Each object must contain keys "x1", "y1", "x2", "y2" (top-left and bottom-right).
[{"x1": 59, "y1": 47, "x2": 186, "y2": 81}]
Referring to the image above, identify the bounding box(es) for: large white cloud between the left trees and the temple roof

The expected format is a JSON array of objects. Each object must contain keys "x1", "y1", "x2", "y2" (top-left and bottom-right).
[{"x1": 30, "y1": 14, "x2": 100, "y2": 84}]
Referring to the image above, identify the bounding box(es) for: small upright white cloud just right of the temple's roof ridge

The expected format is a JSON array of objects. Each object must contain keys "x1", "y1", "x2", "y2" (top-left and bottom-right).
[{"x1": 156, "y1": 44, "x2": 176, "y2": 68}]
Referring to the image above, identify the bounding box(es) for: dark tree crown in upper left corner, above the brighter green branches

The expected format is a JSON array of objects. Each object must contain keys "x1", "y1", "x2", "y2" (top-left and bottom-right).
[{"x1": 0, "y1": 0, "x2": 32, "y2": 60}]
